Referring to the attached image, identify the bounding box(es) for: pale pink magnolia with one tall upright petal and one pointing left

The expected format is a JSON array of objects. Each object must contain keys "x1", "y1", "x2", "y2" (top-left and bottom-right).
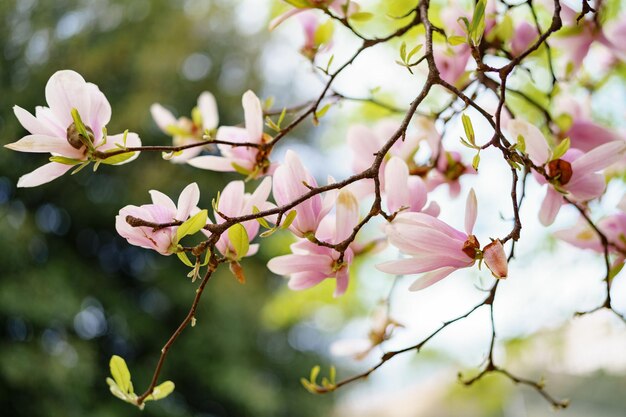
[{"x1": 187, "y1": 90, "x2": 271, "y2": 178}]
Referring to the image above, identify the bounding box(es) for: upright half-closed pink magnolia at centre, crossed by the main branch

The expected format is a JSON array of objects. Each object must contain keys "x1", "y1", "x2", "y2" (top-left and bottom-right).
[{"x1": 273, "y1": 150, "x2": 334, "y2": 237}]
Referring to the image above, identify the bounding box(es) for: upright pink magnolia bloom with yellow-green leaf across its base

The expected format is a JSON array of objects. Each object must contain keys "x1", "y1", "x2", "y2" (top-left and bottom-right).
[{"x1": 202, "y1": 177, "x2": 272, "y2": 258}]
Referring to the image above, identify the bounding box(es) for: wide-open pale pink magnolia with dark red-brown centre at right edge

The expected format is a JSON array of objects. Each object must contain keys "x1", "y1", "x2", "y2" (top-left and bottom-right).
[{"x1": 508, "y1": 119, "x2": 626, "y2": 226}]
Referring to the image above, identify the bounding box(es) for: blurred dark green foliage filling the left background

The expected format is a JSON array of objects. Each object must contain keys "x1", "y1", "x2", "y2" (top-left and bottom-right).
[{"x1": 0, "y1": 0, "x2": 332, "y2": 417}]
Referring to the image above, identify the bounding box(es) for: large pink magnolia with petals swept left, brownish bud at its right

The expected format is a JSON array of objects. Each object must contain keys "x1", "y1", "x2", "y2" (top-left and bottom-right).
[{"x1": 376, "y1": 190, "x2": 506, "y2": 291}]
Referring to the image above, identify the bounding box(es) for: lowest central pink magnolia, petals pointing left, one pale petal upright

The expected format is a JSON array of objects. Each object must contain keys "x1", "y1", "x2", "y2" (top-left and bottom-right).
[{"x1": 267, "y1": 189, "x2": 359, "y2": 297}]
